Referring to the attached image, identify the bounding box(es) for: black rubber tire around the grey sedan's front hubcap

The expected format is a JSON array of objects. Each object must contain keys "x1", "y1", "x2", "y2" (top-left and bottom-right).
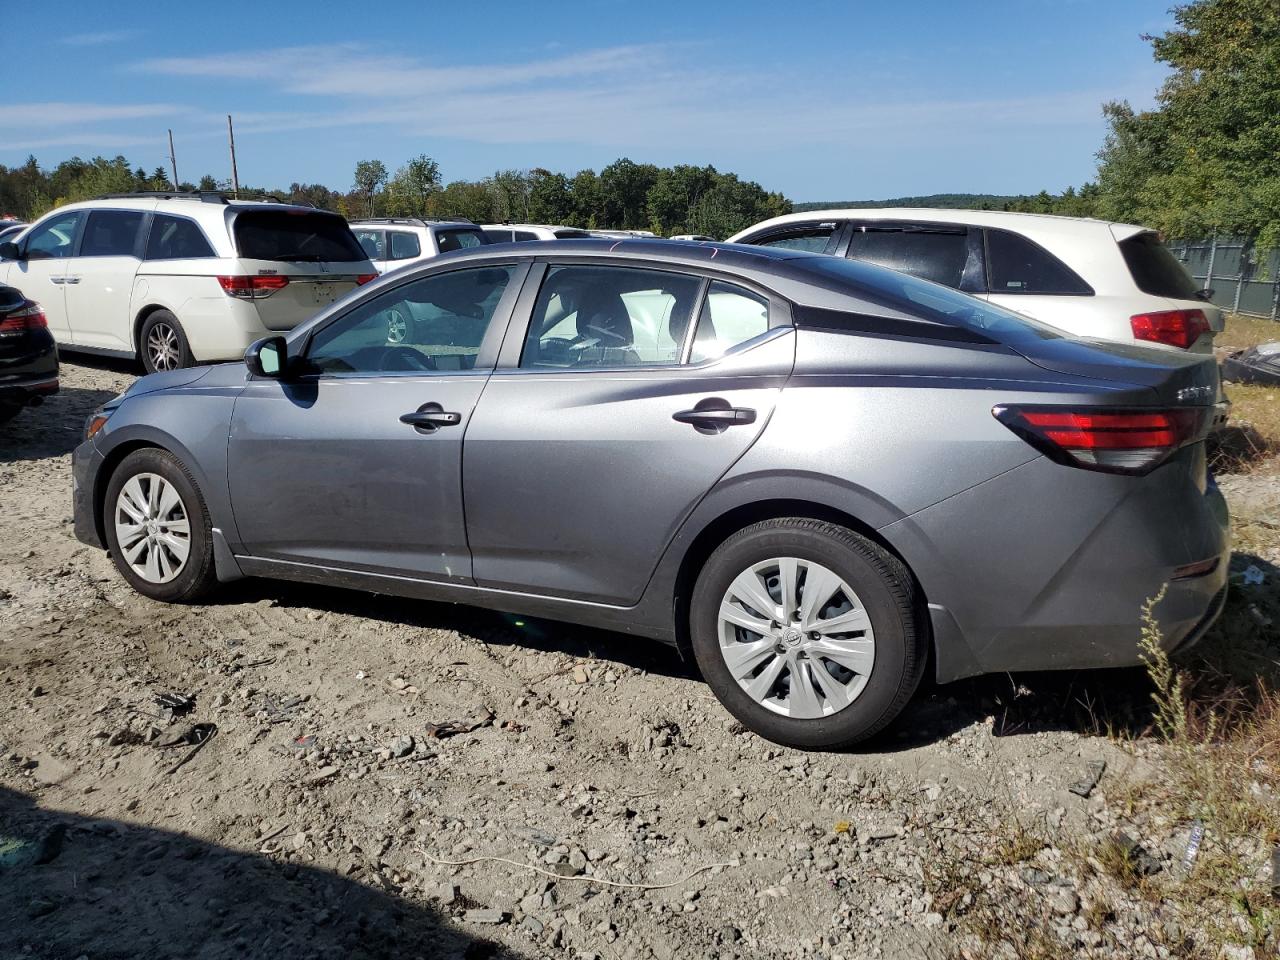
[{"x1": 102, "y1": 447, "x2": 218, "y2": 603}]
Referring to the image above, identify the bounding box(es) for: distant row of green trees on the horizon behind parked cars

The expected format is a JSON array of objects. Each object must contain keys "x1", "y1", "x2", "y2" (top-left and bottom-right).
[{"x1": 0, "y1": 155, "x2": 791, "y2": 239}]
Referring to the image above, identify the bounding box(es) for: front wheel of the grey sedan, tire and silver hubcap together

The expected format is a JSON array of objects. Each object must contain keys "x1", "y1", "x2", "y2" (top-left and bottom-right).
[{"x1": 102, "y1": 448, "x2": 216, "y2": 603}]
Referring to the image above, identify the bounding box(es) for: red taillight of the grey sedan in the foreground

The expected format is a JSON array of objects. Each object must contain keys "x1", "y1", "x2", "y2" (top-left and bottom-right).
[{"x1": 991, "y1": 404, "x2": 1212, "y2": 474}]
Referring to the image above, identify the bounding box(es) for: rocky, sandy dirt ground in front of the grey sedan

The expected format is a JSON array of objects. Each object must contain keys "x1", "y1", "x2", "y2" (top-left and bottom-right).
[{"x1": 0, "y1": 358, "x2": 1280, "y2": 960}]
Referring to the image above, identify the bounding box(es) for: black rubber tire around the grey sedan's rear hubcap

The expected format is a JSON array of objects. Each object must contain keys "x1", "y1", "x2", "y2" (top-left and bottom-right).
[{"x1": 689, "y1": 517, "x2": 928, "y2": 750}]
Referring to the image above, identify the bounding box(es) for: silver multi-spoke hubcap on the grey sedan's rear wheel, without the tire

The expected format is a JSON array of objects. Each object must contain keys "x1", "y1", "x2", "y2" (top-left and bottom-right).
[{"x1": 719, "y1": 557, "x2": 876, "y2": 719}]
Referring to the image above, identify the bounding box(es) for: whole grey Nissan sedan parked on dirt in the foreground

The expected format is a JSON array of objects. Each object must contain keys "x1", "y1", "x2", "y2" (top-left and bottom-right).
[{"x1": 74, "y1": 239, "x2": 1229, "y2": 749}]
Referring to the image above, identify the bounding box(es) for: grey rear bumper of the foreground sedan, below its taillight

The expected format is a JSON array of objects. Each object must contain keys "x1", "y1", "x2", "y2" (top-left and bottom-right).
[{"x1": 882, "y1": 448, "x2": 1230, "y2": 682}]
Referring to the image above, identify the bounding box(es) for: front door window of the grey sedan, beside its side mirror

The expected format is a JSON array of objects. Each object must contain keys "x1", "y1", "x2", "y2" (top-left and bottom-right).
[{"x1": 307, "y1": 266, "x2": 515, "y2": 374}]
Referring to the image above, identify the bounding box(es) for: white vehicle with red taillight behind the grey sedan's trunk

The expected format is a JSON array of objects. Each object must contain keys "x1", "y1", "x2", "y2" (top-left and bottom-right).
[{"x1": 730, "y1": 209, "x2": 1224, "y2": 353}]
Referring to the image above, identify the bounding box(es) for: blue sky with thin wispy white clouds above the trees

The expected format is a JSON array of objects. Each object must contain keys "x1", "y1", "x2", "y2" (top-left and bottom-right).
[{"x1": 0, "y1": 0, "x2": 1171, "y2": 201}]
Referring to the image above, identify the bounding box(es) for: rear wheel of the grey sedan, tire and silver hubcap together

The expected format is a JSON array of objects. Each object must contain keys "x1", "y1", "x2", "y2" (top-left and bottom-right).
[{"x1": 690, "y1": 518, "x2": 927, "y2": 750}]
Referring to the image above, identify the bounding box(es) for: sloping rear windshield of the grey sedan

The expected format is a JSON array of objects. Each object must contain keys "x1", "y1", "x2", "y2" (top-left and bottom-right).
[{"x1": 790, "y1": 256, "x2": 1065, "y2": 344}]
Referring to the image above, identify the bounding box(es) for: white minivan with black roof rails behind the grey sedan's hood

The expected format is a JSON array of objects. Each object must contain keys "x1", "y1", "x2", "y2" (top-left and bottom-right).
[{"x1": 0, "y1": 193, "x2": 376, "y2": 372}]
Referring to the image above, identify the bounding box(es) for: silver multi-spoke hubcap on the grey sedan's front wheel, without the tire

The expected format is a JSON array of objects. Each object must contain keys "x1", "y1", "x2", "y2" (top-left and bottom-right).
[{"x1": 115, "y1": 474, "x2": 191, "y2": 584}]
